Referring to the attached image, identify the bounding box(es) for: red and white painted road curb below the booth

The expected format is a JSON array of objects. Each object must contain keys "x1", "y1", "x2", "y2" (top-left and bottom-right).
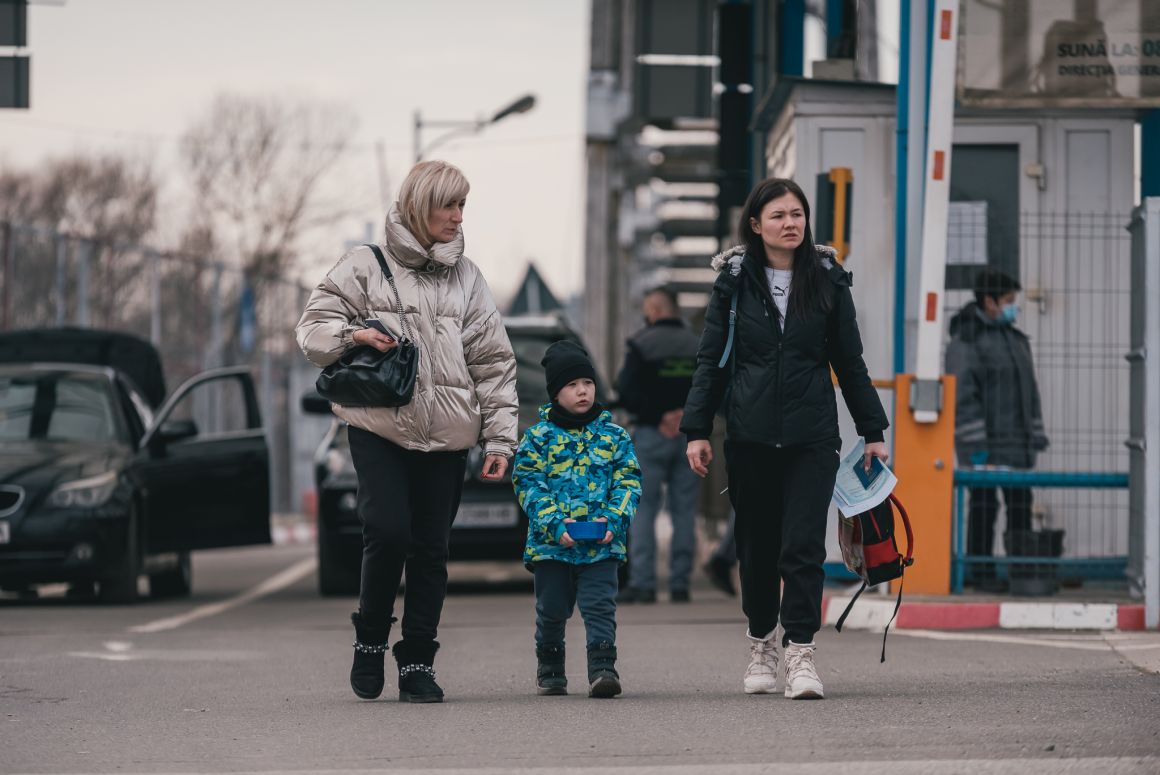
[{"x1": 821, "y1": 595, "x2": 1144, "y2": 631}]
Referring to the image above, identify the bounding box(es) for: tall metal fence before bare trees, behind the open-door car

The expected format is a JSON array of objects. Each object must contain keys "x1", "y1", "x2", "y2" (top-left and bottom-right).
[{"x1": 0, "y1": 223, "x2": 310, "y2": 510}]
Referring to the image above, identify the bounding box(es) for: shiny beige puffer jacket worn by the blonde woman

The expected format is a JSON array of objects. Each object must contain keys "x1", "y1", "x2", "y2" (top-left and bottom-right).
[{"x1": 295, "y1": 207, "x2": 519, "y2": 457}]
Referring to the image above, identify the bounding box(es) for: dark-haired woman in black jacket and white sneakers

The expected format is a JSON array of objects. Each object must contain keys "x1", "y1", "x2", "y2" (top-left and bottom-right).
[{"x1": 681, "y1": 179, "x2": 889, "y2": 698}]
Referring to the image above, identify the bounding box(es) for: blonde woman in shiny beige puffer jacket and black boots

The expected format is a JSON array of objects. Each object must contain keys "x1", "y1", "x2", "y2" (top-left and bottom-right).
[{"x1": 296, "y1": 161, "x2": 519, "y2": 702}]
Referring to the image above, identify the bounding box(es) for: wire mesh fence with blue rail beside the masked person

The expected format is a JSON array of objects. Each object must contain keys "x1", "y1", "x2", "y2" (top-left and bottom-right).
[{"x1": 948, "y1": 213, "x2": 1133, "y2": 591}]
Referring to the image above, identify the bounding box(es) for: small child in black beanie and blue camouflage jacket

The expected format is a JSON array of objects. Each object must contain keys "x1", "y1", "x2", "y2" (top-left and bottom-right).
[{"x1": 512, "y1": 341, "x2": 640, "y2": 697}]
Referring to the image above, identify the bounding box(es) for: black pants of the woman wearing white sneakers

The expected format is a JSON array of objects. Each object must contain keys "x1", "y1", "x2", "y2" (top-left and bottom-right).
[{"x1": 725, "y1": 439, "x2": 840, "y2": 644}]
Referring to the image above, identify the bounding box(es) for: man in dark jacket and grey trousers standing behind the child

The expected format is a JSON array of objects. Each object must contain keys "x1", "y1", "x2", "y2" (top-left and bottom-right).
[{"x1": 617, "y1": 288, "x2": 701, "y2": 603}]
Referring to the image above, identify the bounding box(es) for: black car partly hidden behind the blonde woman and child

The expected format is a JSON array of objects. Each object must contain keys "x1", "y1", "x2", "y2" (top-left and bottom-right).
[{"x1": 303, "y1": 316, "x2": 603, "y2": 595}]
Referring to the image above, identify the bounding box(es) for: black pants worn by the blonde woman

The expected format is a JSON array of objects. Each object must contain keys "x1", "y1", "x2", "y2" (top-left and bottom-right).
[{"x1": 348, "y1": 427, "x2": 467, "y2": 640}]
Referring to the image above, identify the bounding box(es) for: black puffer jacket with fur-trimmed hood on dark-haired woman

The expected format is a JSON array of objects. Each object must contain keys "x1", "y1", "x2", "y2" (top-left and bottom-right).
[{"x1": 681, "y1": 246, "x2": 890, "y2": 447}]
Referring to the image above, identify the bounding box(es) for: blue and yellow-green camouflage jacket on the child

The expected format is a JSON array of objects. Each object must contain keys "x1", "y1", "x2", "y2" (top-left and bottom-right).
[{"x1": 512, "y1": 404, "x2": 640, "y2": 570}]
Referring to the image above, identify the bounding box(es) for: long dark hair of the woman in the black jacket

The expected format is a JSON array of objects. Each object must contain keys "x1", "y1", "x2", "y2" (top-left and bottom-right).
[{"x1": 737, "y1": 178, "x2": 833, "y2": 318}]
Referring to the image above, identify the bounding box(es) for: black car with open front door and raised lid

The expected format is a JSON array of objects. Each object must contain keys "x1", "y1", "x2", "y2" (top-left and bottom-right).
[{"x1": 0, "y1": 328, "x2": 270, "y2": 602}]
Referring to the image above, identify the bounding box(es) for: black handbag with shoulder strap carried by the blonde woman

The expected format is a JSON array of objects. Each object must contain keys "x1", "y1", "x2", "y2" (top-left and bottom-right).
[{"x1": 314, "y1": 245, "x2": 419, "y2": 407}]
